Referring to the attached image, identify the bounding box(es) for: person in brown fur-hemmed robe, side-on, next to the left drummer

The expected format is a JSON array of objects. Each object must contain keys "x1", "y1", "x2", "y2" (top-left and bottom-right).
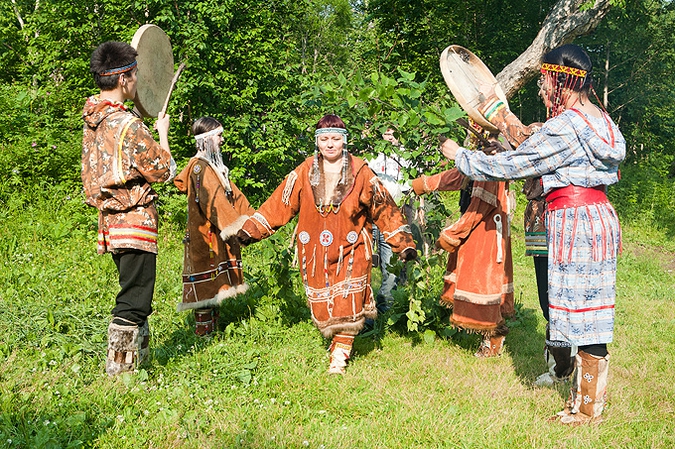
[{"x1": 174, "y1": 117, "x2": 255, "y2": 335}]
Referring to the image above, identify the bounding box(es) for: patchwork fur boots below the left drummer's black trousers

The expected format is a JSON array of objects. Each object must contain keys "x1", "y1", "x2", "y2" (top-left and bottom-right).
[{"x1": 105, "y1": 321, "x2": 144, "y2": 376}]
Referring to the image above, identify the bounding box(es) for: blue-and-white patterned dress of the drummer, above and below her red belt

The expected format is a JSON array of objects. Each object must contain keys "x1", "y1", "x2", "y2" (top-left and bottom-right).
[{"x1": 455, "y1": 110, "x2": 626, "y2": 346}]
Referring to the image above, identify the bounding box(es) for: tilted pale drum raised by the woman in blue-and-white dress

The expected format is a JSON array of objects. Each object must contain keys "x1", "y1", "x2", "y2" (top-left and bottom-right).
[{"x1": 440, "y1": 45, "x2": 508, "y2": 131}]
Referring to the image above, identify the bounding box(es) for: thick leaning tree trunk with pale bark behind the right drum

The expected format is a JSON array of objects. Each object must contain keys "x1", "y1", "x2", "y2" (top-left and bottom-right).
[{"x1": 496, "y1": 0, "x2": 611, "y2": 98}]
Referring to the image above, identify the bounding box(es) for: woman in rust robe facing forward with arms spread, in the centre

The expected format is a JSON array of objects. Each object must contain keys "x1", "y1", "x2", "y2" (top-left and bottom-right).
[{"x1": 238, "y1": 115, "x2": 417, "y2": 374}]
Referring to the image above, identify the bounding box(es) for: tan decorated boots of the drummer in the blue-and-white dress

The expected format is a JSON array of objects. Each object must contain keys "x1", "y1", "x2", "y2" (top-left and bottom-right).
[{"x1": 558, "y1": 351, "x2": 609, "y2": 425}]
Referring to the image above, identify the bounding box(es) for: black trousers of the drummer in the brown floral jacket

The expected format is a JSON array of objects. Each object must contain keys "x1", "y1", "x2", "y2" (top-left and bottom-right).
[{"x1": 112, "y1": 250, "x2": 157, "y2": 325}]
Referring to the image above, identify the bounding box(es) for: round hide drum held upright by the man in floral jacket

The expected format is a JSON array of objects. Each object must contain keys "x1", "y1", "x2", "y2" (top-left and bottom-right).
[{"x1": 131, "y1": 24, "x2": 173, "y2": 117}]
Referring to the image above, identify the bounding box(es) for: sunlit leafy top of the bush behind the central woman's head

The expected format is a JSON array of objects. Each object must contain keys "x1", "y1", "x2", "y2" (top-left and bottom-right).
[{"x1": 300, "y1": 70, "x2": 464, "y2": 178}]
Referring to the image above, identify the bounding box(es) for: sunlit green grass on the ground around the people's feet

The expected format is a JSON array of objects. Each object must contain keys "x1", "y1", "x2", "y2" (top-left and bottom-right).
[{"x1": 0, "y1": 183, "x2": 675, "y2": 448}]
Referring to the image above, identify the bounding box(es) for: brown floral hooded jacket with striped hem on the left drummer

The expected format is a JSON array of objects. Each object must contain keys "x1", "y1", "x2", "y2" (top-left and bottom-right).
[{"x1": 82, "y1": 95, "x2": 175, "y2": 254}]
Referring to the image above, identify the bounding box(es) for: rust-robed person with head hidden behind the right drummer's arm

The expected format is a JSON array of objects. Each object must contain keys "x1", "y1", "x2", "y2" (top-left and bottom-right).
[{"x1": 412, "y1": 131, "x2": 514, "y2": 357}]
